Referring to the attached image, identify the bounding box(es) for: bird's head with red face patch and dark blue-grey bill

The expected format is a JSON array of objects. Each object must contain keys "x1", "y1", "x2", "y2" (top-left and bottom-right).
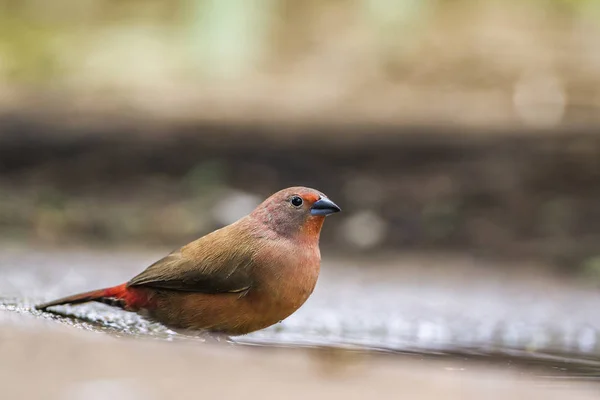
[{"x1": 250, "y1": 186, "x2": 341, "y2": 239}]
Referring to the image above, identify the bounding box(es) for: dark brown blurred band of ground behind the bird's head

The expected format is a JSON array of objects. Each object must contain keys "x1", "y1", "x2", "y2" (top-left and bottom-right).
[{"x1": 0, "y1": 118, "x2": 600, "y2": 277}]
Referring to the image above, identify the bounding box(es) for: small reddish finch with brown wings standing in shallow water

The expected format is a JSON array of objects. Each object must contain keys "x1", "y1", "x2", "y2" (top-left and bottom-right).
[{"x1": 35, "y1": 186, "x2": 341, "y2": 337}]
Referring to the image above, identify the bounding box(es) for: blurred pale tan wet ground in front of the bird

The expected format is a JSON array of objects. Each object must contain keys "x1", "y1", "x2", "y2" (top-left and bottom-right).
[{"x1": 0, "y1": 320, "x2": 598, "y2": 400}]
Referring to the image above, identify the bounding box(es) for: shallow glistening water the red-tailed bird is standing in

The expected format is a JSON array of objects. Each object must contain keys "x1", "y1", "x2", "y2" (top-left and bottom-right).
[{"x1": 0, "y1": 248, "x2": 600, "y2": 382}]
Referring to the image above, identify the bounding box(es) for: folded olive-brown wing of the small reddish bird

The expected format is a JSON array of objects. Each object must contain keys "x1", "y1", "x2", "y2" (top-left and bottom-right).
[{"x1": 128, "y1": 228, "x2": 254, "y2": 294}]
